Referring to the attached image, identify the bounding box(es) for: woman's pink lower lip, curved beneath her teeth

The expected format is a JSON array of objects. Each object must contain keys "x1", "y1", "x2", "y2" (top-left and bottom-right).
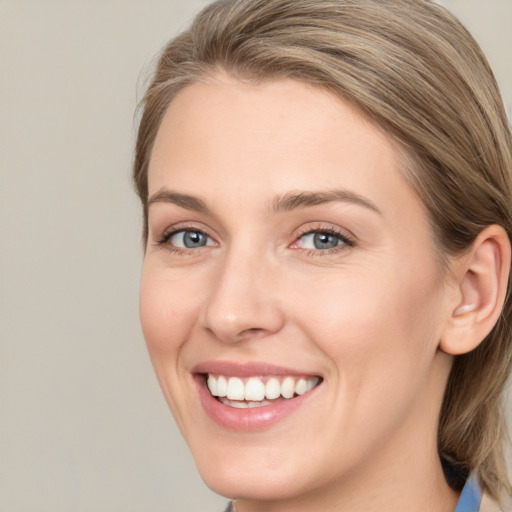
[{"x1": 195, "y1": 375, "x2": 316, "y2": 432}]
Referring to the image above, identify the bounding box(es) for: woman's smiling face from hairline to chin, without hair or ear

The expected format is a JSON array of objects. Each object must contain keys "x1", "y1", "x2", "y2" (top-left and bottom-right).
[{"x1": 140, "y1": 75, "x2": 450, "y2": 500}]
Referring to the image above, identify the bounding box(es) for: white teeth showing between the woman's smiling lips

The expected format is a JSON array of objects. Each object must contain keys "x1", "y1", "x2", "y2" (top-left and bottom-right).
[{"x1": 204, "y1": 374, "x2": 322, "y2": 409}]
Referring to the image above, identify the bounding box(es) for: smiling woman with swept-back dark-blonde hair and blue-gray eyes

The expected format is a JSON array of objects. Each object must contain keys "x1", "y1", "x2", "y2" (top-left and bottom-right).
[{"x1": 134, "y1": 0, "x2": 512, "y2": 512}]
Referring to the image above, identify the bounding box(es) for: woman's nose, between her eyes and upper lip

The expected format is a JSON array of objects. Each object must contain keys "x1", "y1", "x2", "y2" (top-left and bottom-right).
[{"x1": 201, "y1": 251, "x2": 285, "y2": 343}]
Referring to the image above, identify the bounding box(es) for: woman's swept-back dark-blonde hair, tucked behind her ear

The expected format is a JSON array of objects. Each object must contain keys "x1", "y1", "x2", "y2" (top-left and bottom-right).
[{"x1": 134, "y1": 0, "x2": 512, "y2": 498}]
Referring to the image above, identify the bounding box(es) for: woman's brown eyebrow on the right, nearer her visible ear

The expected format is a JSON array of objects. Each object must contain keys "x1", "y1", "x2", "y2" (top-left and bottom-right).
[{"x1": 272, "y1": 190, "x2": 382, "y2": 215}]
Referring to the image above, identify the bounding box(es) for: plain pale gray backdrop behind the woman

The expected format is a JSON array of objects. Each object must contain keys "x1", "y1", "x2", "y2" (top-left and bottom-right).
[{"x1": 0, "y1": 0, "x2": 512, "y2": 512}]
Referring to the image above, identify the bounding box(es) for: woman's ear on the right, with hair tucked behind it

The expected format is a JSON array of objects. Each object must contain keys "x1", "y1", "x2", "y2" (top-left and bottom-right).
[{"x1": 439, "y1": 225, "x2": 511, "y2": 355}]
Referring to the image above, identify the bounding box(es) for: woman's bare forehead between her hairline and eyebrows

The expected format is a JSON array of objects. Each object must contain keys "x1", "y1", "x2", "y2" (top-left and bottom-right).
[{"x1": 149, "y1": 75, "x2": 408, "y2": 200}]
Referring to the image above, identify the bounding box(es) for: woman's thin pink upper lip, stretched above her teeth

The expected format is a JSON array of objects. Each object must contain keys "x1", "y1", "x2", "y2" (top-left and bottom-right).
[{"x1": 192, "y1": 361, "x2": 320, "y2": 377}]
